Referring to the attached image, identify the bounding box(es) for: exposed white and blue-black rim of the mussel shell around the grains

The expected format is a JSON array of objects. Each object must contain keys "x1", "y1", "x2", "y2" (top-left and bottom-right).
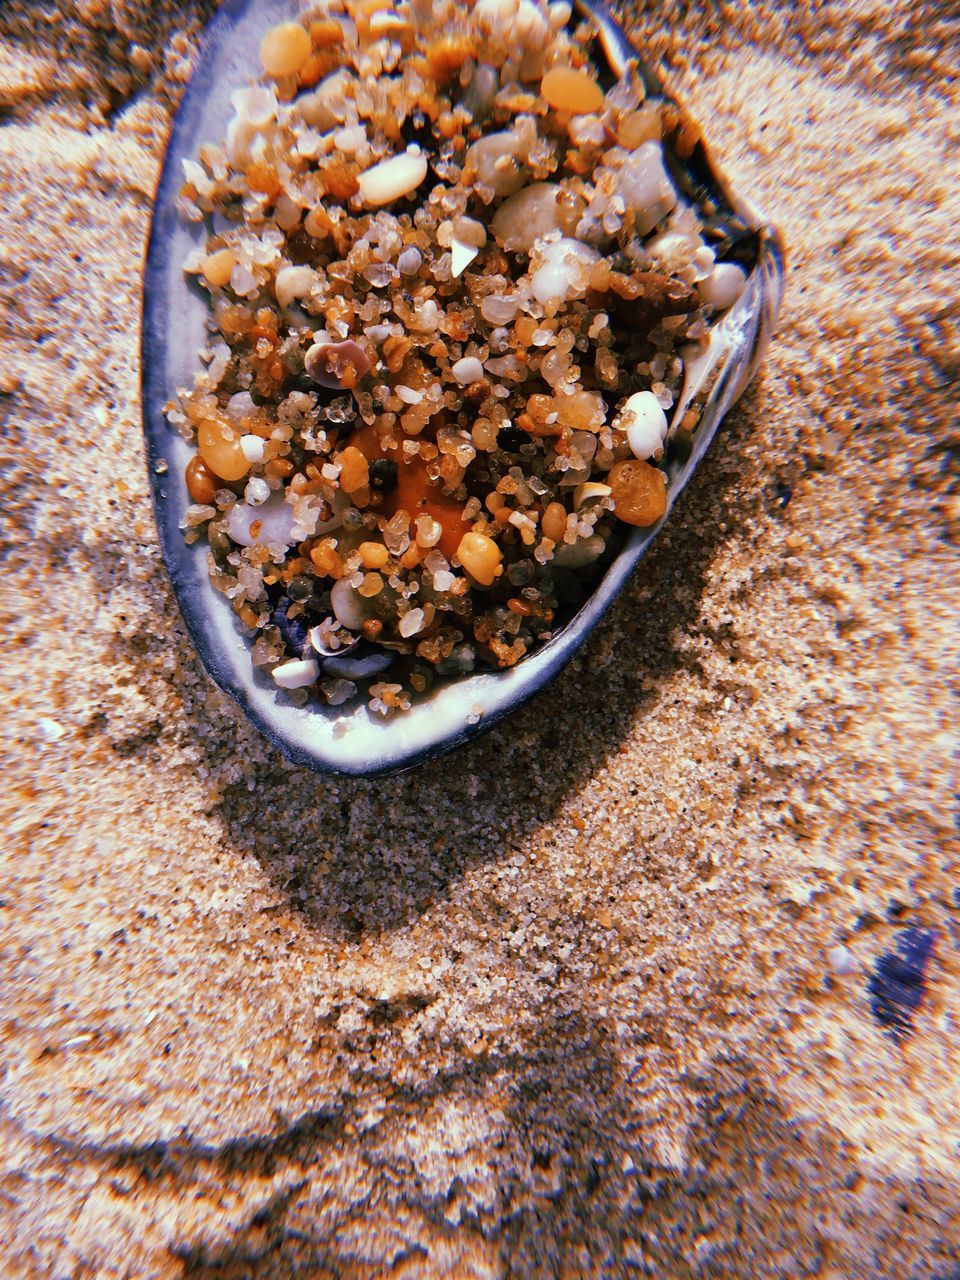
[{"x1": 142, "y1": 0, "x2": 783, "y2": 777}]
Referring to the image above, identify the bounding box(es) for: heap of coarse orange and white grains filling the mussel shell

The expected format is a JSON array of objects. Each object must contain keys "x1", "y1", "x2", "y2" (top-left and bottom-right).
[{"x1": 168, "y1": 0, "x2": 745, "y2": 716}]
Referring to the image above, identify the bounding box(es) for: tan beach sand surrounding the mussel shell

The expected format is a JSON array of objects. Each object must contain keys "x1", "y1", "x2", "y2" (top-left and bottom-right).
[{"x1": 0, "y1": 0, "x2": 960, "y2": 1280}]
